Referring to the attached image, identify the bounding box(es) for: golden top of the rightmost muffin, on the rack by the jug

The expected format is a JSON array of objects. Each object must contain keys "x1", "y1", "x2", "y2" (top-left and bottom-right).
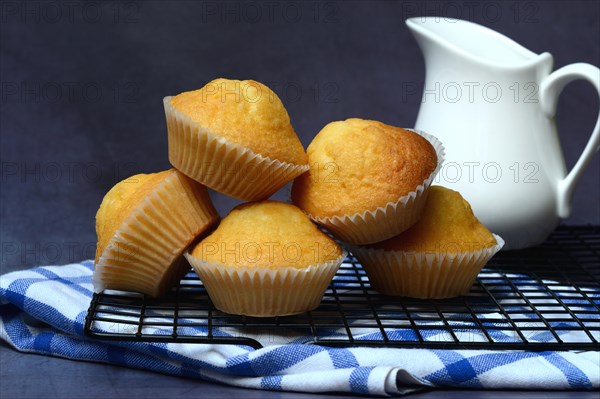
[{"x1": 371, "y1": 186, "x2": 497, "y2": 253}]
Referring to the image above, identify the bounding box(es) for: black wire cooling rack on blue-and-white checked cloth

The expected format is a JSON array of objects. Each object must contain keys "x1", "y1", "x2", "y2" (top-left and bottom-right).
[{"x1": 85, "y1": 226, "x2": 600, "y2": 351}]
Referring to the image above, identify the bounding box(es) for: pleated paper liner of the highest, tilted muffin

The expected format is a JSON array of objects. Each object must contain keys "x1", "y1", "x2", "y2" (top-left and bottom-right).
[{"x1": 163, "y1": 97, "x2": 309, "y2": 201}]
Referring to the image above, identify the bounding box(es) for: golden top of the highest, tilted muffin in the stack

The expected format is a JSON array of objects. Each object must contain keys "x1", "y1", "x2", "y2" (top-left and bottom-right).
[{"x1": 171, "y1": 79, "x2": 308, "y2": 165}]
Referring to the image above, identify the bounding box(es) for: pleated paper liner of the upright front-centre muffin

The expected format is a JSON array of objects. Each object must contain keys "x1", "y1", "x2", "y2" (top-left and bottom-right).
[{"x1": 185, "y1": 252, "x2": 346, "y2": 317}]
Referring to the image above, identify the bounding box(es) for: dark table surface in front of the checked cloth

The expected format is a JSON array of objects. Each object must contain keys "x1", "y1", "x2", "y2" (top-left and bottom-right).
[{"x1": 0, "y1": 343, "x2": 598, "y2": 399}]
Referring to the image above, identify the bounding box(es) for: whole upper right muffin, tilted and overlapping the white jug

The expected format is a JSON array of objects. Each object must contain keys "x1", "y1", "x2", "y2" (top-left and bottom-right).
[{"x1": 292, "y1": 118, "x2": 443, "y2": 244}]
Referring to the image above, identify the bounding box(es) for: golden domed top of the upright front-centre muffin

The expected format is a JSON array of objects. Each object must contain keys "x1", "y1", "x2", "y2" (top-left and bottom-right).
[{"x1": 192, "y1": 200, "x2": 342, "y2": 269}]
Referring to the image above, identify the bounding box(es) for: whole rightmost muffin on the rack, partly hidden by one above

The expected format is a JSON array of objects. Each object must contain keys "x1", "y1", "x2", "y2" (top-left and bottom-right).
[{"x1": 351, "y1": 186, "x2": 504, "y2": 298}]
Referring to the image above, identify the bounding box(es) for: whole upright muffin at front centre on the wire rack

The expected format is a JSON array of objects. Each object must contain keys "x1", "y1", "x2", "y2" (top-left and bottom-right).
[{"x1": 186, "y1": 201, "x2": 345, "y2": 317}]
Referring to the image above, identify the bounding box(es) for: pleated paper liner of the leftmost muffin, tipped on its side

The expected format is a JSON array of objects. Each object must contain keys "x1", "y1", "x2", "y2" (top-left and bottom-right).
[{"x1": 93, "y1": 171, "x2": 219, "y2": 297}]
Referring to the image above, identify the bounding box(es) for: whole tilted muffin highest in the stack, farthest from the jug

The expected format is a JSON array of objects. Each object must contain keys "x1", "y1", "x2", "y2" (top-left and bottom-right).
[{"x1": 163, "y1": 79, "x2": 308, "y2": 201}]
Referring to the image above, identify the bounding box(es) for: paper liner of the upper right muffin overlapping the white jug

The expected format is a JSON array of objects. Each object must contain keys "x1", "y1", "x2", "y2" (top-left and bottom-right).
[{"x1": 308, "y1": 129, "x2": 445, "y2": 245}]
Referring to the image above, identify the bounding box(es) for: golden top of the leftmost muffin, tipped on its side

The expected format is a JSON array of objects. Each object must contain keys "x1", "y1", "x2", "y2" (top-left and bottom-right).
[{"x1": 96, "y1": 169, "x2": 172, "y2": 262}]
